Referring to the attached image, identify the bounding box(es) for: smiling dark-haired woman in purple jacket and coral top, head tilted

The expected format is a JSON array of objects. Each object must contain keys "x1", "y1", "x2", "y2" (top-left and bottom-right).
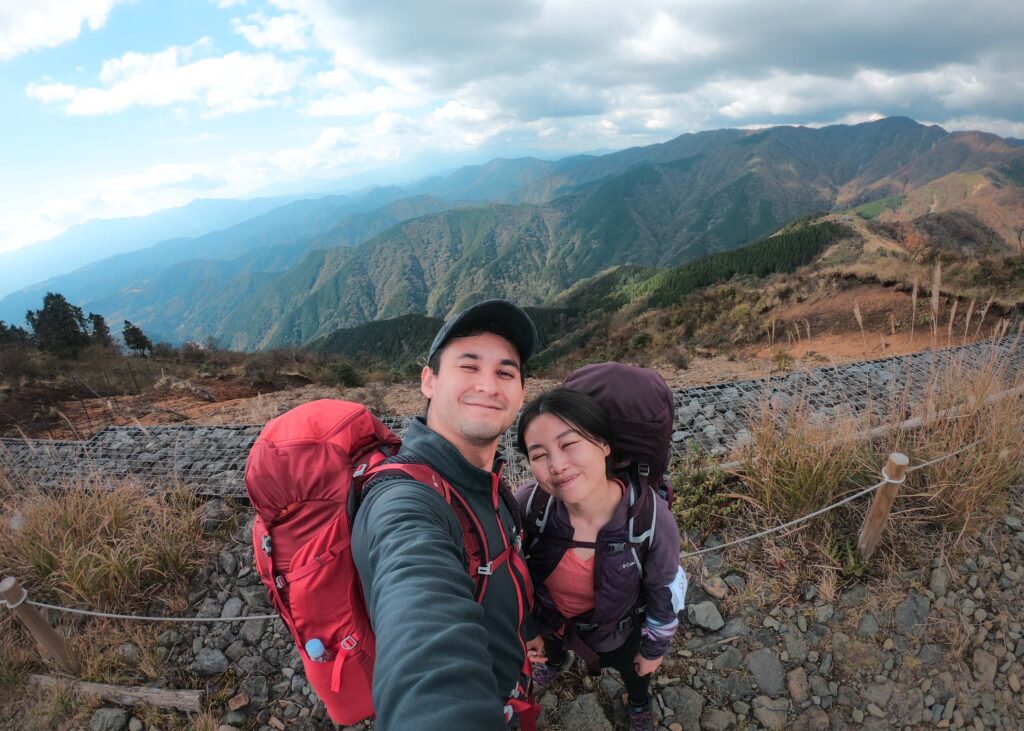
[{"x1": 516, "y1": 388, "x2": 686, "y2": 731}]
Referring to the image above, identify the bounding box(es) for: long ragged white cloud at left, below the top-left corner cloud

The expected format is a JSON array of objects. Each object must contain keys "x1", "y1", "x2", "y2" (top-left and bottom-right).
[{"x1": 26, "y1": 39, "x2": 305, "y2": 117}]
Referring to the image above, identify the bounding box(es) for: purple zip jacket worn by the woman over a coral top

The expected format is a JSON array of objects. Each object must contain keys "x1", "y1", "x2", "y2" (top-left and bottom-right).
[{"x1": 516, "y1": 480, "x2": 686, "y2": 659}]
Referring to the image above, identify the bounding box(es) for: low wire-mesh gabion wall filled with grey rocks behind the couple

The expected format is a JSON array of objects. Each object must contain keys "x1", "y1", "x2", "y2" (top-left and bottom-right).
[{"x1": 0, "y1": 336, "x2": 1024, "y2": 497}]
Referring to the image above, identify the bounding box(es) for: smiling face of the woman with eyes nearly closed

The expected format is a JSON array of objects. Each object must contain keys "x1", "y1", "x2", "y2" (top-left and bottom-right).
[{"x1": 524, "y1": 414, "x2": 611, "y2": 504}]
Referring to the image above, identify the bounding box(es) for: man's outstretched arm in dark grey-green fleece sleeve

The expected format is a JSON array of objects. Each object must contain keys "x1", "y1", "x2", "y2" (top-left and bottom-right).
[{"x1": 352, "y1": 480, "x2": 506, "y2": 731}]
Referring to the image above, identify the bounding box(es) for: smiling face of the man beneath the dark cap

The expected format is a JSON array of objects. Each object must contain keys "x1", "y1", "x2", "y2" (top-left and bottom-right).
[{"x1": 420, "y1": 333, "x2": 523, "y2": 449}]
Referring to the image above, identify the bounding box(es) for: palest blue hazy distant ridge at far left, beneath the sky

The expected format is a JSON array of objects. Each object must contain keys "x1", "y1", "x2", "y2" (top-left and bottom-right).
[{"x1": 0, "y1": 197, "x2": 295, "y2": 301}]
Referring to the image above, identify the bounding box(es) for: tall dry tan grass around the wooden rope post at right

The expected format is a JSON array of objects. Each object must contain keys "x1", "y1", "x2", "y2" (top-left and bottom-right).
[{"x1": 700, "y1": 329, "x2": 1024, "y2": 610}]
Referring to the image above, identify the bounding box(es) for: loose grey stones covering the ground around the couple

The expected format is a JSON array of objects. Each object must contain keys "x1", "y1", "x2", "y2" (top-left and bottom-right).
[{"x1": 72, "y1": 479, "x2": 1024, "y2": 731}]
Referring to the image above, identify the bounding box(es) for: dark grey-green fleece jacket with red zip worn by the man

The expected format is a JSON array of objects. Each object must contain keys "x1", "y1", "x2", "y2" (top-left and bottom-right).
[{"x1": 352, "y1": 420, "x2": 529, "y2": 731}]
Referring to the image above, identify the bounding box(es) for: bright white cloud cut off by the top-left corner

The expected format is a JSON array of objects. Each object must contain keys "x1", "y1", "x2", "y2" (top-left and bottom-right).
[{"x1": 0, "y1": 0, "x2": 119, "y2": 60}]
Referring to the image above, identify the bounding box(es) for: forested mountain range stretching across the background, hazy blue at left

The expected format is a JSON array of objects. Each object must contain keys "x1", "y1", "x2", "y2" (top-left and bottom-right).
[{"x1": 0, "y1": 118, "x2": 1024, "y2": 349}]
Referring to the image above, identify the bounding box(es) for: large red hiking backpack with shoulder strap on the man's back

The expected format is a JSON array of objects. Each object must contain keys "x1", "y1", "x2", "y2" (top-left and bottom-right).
[{"x1": 246, "y1": 399, "x2": 503, "y2": 725}]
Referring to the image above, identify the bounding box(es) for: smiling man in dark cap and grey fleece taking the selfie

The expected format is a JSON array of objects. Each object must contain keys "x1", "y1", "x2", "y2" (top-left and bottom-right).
[{"x1": 352, "y1": 300, "x2": 537, "y2": 731}]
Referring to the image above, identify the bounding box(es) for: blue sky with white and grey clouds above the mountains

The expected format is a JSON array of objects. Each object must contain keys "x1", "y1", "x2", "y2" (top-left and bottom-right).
[{"x1": 0, "y1": 0, "x2": 1024, "y2": 252}]
